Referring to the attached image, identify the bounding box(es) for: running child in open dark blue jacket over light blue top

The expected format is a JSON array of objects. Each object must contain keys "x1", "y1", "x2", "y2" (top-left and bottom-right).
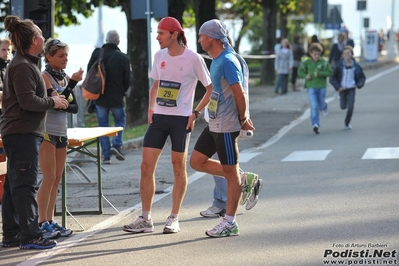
[{"x1": 330, "y1": 45, "x2": 366, "y2": 129}]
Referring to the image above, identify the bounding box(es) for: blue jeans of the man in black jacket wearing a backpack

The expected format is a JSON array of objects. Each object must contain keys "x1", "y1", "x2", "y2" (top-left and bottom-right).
[{"x1": 96, "y1": 105, "x2": 126, "y2": 158}]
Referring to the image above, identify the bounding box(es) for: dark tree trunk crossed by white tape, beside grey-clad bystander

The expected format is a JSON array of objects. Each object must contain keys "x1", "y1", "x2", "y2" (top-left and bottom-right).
[{"x1": 260, "y1": 0, "x2": 277, "y2": 84}]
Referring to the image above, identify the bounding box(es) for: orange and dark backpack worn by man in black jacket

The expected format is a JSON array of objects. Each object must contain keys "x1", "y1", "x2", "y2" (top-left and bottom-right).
[{"x1": 82, "y1": 48, "x2": 106, "y2": 100}]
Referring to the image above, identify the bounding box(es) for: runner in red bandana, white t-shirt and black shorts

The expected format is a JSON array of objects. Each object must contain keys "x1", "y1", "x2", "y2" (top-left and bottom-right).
[{"x1": 123, "y1": 17, "x2": 212, "y2": 234}]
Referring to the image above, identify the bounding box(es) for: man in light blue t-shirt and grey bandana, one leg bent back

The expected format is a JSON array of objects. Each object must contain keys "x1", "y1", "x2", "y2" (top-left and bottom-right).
[{"x1": 190, "y1": 19, "x2": 257, "y2": 237}]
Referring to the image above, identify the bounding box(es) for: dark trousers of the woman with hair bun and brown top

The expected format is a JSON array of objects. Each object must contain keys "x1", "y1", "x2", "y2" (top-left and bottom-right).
[{"x1": 1, "y1": 134, "x2": 43, "y2": 243}]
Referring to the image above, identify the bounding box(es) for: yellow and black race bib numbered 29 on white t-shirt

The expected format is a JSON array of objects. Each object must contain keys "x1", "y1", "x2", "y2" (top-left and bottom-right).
[{"x1": 157, "y1": 80, "x2": 181, "y2": 107}]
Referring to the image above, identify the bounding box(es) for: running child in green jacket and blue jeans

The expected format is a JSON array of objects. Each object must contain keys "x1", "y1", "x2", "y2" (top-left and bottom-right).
[{"x1": 298, "y1": 43, "x2": 332, "y2": 134}]
